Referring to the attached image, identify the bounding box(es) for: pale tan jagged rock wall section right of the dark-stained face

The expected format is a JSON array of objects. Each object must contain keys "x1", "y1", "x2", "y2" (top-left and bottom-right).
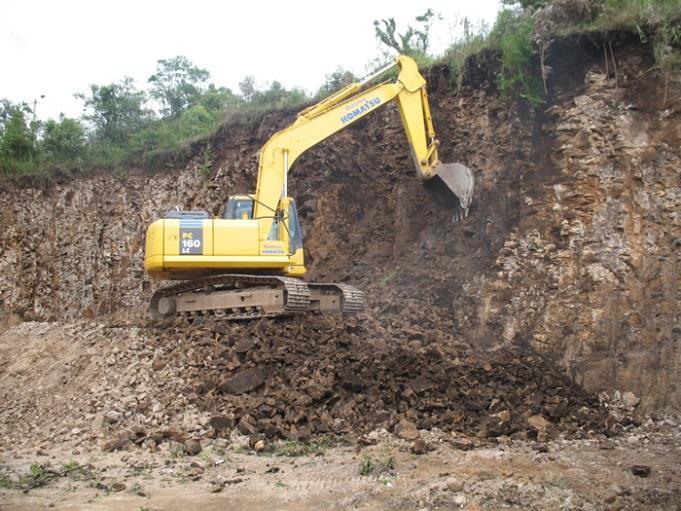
[{"x1": 462, "y1": 54, "x2": 681, "y2": 408}]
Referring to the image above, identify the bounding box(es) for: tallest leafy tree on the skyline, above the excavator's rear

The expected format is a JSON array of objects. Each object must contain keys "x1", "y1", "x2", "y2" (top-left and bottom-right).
[{"x1": 148, "y1": 55, "x2": 210, "y2": 117}]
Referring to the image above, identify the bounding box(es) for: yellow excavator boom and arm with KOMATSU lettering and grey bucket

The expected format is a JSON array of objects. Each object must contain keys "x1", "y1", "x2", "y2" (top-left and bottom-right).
[{"x1": 253, "y1": 56, "x2": 473, "y2": 239}]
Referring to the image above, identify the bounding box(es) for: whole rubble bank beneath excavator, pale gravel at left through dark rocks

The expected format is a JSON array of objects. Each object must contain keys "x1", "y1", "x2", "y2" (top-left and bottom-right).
[{"x1": 0, "y1": 311, "x2": 634, "y2": 456}]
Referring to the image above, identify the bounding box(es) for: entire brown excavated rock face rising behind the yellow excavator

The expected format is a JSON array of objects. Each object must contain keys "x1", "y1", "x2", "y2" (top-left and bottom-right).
[{"x1": 0, "y1": 39, "x2": 681, "y2": 412}]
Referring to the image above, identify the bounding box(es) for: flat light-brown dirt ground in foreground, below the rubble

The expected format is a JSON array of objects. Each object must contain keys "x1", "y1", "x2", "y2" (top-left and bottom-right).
[{"x1": 0, "y1": 424, "x2": 681, "y2": 511}]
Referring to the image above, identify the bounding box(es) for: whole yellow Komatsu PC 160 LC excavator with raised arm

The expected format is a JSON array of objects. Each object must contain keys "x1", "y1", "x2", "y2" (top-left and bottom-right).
[{"x1": 144, "y1": 56, "x2": 473, "y2": 320}]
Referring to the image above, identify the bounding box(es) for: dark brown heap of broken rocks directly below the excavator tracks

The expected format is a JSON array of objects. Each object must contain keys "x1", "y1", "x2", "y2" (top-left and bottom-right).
[{"x1": 150, "y1": 318, "x2": 610, "y2": 440}]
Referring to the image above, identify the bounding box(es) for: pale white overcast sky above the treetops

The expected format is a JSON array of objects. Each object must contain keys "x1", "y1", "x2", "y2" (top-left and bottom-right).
[{"x1": 0, "y1": 0, "x2": 498, "y2": 119}]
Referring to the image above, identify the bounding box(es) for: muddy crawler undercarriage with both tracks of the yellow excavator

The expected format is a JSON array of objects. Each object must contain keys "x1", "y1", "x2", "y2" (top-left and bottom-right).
[{"x1": 149, "y1": 274, "x2": 364, "y2": 320}]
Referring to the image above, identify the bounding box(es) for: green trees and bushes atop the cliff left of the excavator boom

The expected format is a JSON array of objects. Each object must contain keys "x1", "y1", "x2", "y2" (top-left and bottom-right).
[{"x1": 0, "y1": 56, "x2": 310, "y2": 179}]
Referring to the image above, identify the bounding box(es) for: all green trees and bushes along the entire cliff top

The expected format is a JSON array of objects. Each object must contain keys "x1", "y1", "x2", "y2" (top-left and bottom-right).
[{"x1": 0, "y1": 0, "x2": 681, "y2": 180}]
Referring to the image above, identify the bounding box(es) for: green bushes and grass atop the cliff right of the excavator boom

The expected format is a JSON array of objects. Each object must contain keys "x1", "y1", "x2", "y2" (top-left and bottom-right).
[{"x1": 434, "y1": 0, "x2": 681, "y2": 108}]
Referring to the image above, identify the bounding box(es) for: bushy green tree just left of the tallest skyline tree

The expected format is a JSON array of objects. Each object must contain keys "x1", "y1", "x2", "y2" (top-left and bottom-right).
[{"x1": 76, "y1": 77, "x2": 151, "y2": 144}]
